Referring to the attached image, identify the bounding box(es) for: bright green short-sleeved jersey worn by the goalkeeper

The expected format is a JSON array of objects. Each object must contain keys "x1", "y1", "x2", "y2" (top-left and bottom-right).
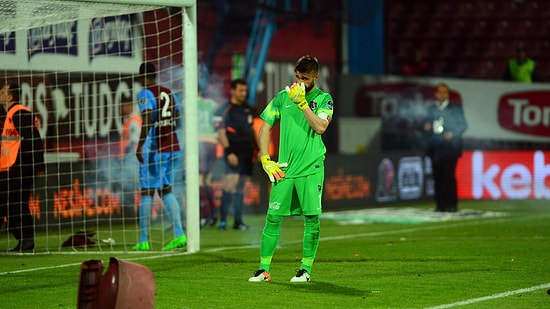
[{"x1": 260, "y1": 88, "x2": 333, "y2": 178}]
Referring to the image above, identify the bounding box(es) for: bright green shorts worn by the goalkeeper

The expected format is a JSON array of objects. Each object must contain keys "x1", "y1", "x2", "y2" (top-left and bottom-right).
[{"x1": 267, "y1": 171, "x2": 325, "y2": 216}]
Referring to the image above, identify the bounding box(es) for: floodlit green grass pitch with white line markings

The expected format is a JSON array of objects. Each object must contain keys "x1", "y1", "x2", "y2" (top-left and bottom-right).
[{"x1": 0, "y1": 201, "x2": 550, "y2": 309}]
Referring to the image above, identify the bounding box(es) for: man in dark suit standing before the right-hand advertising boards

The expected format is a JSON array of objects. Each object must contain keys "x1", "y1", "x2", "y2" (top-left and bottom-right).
[{"x1": 424, "y1": 83, "x2": 468, "y2": 212}]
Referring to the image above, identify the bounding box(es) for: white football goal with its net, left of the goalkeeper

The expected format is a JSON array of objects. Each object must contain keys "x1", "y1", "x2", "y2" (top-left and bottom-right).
[{"x1": 0, "y1": 0, "x2": 200, "y2": 253}]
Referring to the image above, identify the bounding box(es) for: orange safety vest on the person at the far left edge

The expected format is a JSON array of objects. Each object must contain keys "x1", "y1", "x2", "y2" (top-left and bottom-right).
[{"x1": 0, "y1": 104, "x2": 36, "y2": 171}]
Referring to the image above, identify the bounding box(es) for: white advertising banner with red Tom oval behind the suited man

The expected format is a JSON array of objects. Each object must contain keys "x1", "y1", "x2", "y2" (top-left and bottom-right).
[{"x1": 337, "y1": 75, "x2": 550, "y2": 143}]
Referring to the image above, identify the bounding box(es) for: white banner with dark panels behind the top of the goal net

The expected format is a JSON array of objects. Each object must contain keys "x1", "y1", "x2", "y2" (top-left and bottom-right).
[{"x1": 0, "y1": 14, "x2": 143, "y2": 73}]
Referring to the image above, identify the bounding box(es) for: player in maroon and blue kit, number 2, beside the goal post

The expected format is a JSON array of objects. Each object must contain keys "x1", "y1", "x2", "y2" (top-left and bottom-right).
[{"x1": 132, "y1": 62, "x2": 187, "y2": 251}]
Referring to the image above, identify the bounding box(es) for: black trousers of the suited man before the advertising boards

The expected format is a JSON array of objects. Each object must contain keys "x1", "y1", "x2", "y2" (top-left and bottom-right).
[{"x1": 431, "y1": 151, "x2": 458, "y2": 212}]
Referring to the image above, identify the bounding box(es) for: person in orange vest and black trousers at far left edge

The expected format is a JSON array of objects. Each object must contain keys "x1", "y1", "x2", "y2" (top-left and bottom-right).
[{"x1": 0, "y1": 83, "x2": 45, "y2": 252}]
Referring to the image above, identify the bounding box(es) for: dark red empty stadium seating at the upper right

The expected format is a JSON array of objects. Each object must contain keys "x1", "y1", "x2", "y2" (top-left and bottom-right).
[{"x1": 385, "y1": 0, "x2": 550, "y2": 81}]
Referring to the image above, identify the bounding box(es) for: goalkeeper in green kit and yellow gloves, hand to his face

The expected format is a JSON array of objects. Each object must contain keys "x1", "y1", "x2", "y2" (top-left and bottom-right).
[{"x1": 248, "y1": 56, "x2": 333, "y2": 282}]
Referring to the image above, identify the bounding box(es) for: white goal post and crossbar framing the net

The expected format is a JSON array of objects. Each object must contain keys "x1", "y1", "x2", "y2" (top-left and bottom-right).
[{"x1": 0, "y1": 0, "x2": 200, "y2": 252}]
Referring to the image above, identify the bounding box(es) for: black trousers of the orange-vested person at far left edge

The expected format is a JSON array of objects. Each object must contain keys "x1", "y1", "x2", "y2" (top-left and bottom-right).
[{"x1": 0, "y1": 172, "x2": 34, "y2": 240}]
